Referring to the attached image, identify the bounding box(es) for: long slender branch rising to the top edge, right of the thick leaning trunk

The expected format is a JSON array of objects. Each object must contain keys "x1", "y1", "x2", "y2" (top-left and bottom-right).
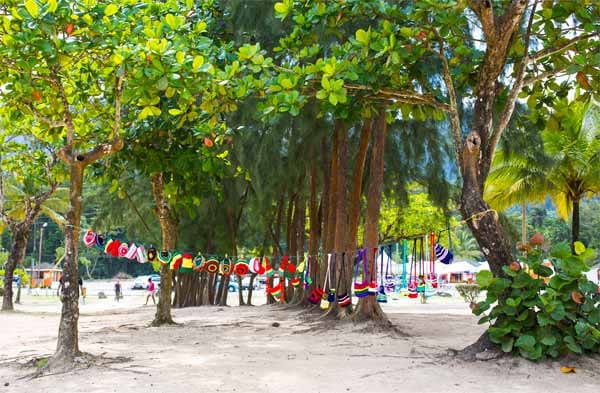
[{"x1": 488, "y1": 0, "x2": 538, "y2": 159}]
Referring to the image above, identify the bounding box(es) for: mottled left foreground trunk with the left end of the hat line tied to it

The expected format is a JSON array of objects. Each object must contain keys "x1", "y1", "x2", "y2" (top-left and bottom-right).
[{"x1": 51, "y1": 161, "x2": 85, "y2": 367}]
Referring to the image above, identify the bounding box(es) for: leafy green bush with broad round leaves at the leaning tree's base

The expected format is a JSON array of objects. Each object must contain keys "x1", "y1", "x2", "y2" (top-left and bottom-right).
[{"x1": 473, "y1": 234, "x2": 600, "y2": 360}]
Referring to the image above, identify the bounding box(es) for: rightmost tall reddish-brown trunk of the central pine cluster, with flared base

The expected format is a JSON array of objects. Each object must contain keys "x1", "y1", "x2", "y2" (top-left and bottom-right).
[{"x1": 353, "y1": 109, "x2": 389, "y2": 323}]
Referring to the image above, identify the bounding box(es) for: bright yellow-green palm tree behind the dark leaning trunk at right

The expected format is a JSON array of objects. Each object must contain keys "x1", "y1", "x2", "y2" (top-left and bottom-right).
[{"x1": 485, "y1": 99, "x2": 600, "y2": 251}]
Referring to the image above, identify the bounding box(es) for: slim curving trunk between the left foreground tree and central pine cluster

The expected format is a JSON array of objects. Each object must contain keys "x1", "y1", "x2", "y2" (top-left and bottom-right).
[{"x1": 151, "y1": 172, "x2": 176, "y2": 326}]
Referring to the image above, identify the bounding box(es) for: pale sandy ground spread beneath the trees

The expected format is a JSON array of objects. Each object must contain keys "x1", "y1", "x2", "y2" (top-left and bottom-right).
[{"x1": 0, "y1": 283, "x2": 600, "y2": 393}]
